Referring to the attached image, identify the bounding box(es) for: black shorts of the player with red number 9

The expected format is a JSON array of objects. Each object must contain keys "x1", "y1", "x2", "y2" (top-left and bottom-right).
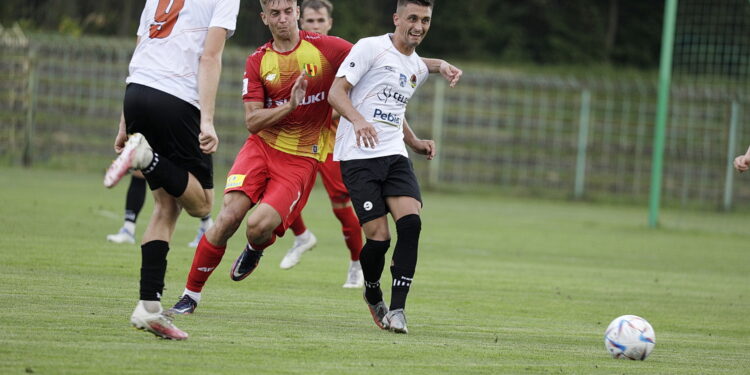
[{"x1": 123, "y1": 83, "x2": 214, "y2": 190}]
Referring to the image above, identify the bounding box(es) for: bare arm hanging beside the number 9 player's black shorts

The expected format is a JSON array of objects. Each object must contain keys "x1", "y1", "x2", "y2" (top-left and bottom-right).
[{"x1": 198, "y1": 27, "x2": 227, "y2": 154}]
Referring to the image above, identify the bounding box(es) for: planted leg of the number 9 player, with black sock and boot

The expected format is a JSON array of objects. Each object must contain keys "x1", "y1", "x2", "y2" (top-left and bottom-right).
[{"x1": 130, "y1": 189, "x2": 188, "y2": 340}]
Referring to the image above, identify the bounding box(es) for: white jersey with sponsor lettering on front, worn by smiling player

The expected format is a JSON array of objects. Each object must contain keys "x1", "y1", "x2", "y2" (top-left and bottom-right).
[{"x1": 333, "y1": 34, "x2": 429, "y2": 160}]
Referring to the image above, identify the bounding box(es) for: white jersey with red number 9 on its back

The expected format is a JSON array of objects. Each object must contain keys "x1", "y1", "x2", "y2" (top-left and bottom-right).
[{"x1": 126, "y1": 0, "x2": 240, "y2": 109}]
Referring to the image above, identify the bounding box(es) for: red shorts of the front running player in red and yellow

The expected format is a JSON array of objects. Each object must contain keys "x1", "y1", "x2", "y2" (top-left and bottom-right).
[{"x1": 224, "y1": 135, "x2": 319, "y2": 237}]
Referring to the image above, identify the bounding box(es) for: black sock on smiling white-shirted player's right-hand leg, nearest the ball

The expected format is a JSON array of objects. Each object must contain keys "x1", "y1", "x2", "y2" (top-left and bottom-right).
[{"x1": 390, "y1": 215, "x2": 422, "y2": 310}]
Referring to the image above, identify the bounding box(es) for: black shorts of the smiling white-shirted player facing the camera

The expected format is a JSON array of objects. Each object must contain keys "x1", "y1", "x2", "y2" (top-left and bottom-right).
[{"x1": 341, "y1": 155, "x2": 422, "y2": 225}]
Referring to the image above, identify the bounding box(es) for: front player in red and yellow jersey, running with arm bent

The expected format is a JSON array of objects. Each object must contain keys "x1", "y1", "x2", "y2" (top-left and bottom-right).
[{"x1": 171, "y1": 0, "x2": 352, "y2": 314}]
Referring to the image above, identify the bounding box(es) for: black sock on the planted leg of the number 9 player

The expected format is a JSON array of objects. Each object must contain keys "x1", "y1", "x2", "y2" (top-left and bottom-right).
[{"x1": 141, "y1": 241, "x2": 169, "y2": 301}]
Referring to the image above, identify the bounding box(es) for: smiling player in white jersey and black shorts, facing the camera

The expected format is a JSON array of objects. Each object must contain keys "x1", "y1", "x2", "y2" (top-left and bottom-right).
[{"x1": 328, "y1": 0, "x2": 462, "y2": 333}]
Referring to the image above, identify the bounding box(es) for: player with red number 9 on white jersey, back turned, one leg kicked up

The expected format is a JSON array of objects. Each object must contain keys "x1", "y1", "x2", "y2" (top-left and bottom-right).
[{"x1": 104, "y1": 0, "x2": 240, "y2": 340}]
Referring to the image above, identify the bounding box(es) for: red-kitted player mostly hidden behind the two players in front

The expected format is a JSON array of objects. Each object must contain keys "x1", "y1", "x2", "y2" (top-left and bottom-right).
[{"x1": 280, "y1": 0, "x2": 364, "y2": 288}]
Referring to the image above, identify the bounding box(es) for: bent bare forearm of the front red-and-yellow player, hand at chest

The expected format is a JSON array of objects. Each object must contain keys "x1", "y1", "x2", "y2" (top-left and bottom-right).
[{"x1": 245, "y1": 74, "x2": 307, "y2": 134}]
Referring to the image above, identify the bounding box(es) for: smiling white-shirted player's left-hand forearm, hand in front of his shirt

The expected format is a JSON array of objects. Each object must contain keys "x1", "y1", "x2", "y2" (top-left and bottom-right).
[{"x1": 328, "y1": 77, "x2": 378, "y2": 148}]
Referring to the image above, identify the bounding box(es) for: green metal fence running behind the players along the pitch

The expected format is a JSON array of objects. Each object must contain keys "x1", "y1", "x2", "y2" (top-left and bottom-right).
[{"x1": 0, "y1": 29, "x2": 750, "y2": 208}]
